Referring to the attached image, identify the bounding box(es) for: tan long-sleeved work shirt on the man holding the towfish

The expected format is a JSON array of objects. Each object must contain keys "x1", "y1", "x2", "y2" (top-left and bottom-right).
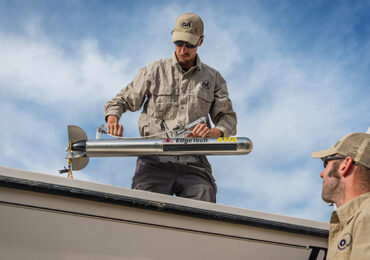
[{"x1": 104, "y1": 55, "x2": 236, "y2": 138}]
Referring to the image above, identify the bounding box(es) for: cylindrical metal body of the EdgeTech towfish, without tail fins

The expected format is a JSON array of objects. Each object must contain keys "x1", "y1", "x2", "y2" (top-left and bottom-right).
[{"x1": 81, "y1": 137, "x2": 253, "y2": 157}]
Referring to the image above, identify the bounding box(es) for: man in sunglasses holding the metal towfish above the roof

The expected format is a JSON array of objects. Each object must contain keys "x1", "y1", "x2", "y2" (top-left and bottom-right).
[{"x1": 104, "y1": 13, "x2": 236, "y2": 202}]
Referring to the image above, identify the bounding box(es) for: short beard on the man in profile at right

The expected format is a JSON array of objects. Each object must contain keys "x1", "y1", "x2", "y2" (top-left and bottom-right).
[{"x1": 321, "y1": 163, "x2": 343, "y2": 203}]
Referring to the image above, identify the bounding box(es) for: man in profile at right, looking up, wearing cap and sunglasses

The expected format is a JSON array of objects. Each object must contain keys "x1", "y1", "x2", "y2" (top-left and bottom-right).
[{"x1": 311, "y1": 133, "x2": 370, "y2": 260}]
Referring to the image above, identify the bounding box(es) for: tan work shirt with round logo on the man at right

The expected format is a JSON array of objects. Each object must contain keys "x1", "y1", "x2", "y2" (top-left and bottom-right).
[{"x1": 327, "y1": 192, "x2": 370, "y2": 260}]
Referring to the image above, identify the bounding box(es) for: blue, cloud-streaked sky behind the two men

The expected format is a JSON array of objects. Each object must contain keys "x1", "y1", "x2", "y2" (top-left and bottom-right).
[{"x1": 0, "y1": 0, "x2": 370, "y2": 221}]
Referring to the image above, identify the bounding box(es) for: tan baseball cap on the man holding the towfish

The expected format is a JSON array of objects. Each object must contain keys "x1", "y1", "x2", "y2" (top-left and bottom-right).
[{"x1": 172, "y1": 13, "x2": 204, "y2": 45}]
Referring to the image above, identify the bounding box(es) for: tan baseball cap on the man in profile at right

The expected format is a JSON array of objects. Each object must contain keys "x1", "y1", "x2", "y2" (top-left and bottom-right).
[{"x1": 311, "y1": 133, "x2": 370, "y2": 168}]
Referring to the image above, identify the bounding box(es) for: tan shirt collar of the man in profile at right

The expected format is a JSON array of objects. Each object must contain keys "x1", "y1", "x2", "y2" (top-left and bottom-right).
[{"x1": 330, "y1": 192, "x2": 370, "y2": 223}]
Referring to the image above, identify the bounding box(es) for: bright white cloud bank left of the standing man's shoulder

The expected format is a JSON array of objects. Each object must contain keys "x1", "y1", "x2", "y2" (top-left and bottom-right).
[{"x1": 0, "y1": 29, "x2": 129, "y2": 105}]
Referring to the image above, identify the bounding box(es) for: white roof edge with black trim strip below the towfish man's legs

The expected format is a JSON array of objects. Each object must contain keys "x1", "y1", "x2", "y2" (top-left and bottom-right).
[{"x1": 0, "y1": 167, "x2": 329, "y2": 237}]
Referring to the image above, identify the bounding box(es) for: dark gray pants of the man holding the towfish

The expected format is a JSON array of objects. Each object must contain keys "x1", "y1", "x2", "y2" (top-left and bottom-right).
[{"x1": 132, "y1": 155, "x2": 217, "y2": 202}]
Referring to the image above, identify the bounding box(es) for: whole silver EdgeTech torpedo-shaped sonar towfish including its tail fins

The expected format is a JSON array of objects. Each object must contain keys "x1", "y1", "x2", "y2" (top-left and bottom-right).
[{"x1": 65, "y1": 125, "x2": 253, "y2": 171}]
